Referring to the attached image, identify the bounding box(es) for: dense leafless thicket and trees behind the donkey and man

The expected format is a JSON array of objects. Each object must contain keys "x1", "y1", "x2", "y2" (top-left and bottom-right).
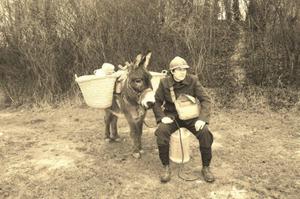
[{"x1": 0, "y1": 0, "x2": 300, "y2": 109}]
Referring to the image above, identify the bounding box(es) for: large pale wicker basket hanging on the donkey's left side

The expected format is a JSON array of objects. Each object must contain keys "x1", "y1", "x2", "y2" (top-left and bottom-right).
[{"x1": 75, "y1": 75, "x2": 117, "y2": 109}]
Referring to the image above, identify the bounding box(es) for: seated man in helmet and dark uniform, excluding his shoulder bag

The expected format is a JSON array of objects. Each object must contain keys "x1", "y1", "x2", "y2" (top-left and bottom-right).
[{"x1": 153, "y1": 57, "x2": 214, "y2": 183}]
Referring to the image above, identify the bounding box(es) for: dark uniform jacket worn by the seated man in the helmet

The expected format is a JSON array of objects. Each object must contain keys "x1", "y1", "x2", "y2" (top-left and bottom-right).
[{"x1": 153, "y1": 74, "x2": 211, "y2": 123}]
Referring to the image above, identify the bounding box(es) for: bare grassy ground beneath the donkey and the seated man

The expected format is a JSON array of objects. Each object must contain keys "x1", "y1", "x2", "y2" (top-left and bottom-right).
[{"x1": 0, "y1": 106, "x2": 300, "y2": 199}]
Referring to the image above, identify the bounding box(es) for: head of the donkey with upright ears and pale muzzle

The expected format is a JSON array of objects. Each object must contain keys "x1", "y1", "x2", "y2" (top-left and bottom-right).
[{"x1": 121, "y1": 52, "x2": 155, "y2": 108}]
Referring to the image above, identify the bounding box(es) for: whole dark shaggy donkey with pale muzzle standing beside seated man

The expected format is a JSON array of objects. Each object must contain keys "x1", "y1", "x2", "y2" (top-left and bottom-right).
[{"x1": 104, "y1": 52, "x2": 155, "y2": 158}]
